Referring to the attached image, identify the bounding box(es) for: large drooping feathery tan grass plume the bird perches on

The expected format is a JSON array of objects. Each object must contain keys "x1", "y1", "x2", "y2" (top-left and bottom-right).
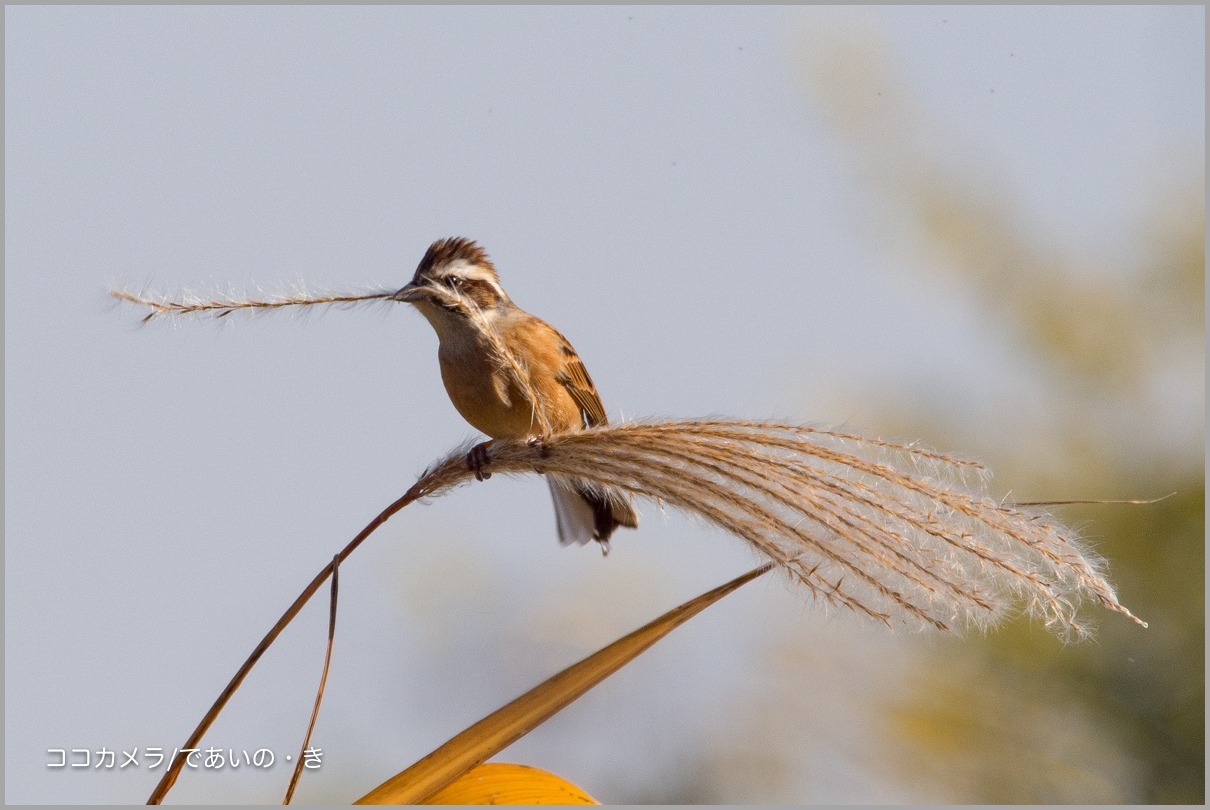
[{"x1": 425, "y1": 420, "x2": 1146, "y2": 638}]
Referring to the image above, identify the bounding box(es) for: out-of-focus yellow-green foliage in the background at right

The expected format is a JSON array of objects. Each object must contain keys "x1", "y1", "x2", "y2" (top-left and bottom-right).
[{"x1": 800, "y1": 14, "x2": 1205, "y2": 804}]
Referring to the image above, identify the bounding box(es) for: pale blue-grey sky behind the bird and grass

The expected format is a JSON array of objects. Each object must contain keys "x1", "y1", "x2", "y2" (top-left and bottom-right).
[{"x1": 5, "y1": 6, "x2": 1205, "y2": 803}]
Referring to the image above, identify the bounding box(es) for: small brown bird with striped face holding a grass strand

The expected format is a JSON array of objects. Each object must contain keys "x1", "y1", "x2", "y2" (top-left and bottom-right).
[{"x1": 394, "y1": 237, "x2": 639, "y2": 553}]
